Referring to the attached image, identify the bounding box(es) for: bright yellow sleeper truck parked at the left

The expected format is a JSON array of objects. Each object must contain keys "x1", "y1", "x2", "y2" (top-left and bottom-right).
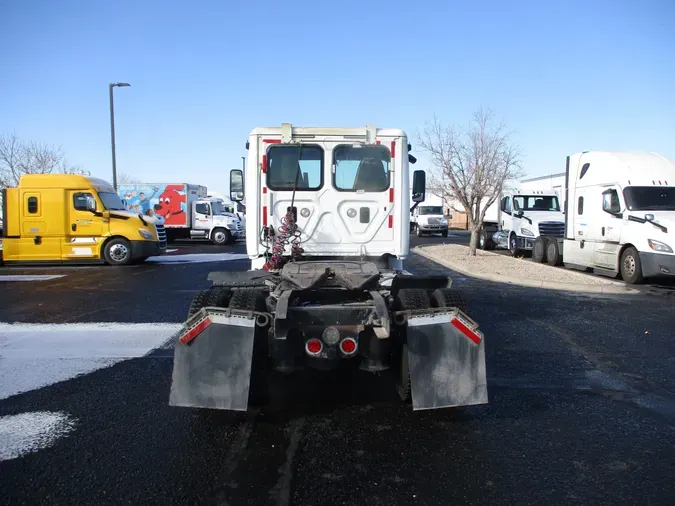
[{"x1": 2, "y1": 174, "x2": 166, "y2": 265}]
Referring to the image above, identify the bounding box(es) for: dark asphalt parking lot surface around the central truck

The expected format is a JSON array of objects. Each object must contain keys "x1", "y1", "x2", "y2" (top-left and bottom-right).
[{"x1": 0, "y1": 238, "x2": 675, "y2": 505}]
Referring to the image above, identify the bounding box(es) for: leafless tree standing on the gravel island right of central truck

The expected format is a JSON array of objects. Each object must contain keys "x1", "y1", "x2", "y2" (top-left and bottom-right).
[{"x1": 418, "y1": 108, "x2": 524, "y2": 256}]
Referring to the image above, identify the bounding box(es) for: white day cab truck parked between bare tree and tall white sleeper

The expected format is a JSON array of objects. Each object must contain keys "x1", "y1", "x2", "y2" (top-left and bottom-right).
[{"x1": 478, "y1": 190, "x2": 565, "y2": 262}]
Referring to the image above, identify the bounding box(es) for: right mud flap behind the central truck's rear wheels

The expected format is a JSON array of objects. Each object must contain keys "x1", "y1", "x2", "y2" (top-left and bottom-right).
[{"x1": 407, "y1": 309, "x2": 488, "y2": 410}]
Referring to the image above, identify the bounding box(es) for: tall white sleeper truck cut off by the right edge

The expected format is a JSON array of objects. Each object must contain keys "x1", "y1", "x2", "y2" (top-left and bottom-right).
[{"x1": 548, "y1": 151, "x2": 675, "y2": 284}]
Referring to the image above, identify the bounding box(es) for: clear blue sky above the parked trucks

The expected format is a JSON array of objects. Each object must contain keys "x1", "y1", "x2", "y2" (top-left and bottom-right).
[{"x1": 0, "y1": 0, "x2": 675, "y2": 195}]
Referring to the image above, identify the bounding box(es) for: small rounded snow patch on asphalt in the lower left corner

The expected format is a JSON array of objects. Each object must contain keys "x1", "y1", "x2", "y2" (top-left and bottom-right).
[{"x1": 0, "y1": 411, "x2": 75, "y2": 462}]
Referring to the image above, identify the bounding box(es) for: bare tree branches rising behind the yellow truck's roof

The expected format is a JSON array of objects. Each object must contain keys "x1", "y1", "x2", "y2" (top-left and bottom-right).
[{"x1": 0, "y1": 134, "x2": 89, "y2": 188}]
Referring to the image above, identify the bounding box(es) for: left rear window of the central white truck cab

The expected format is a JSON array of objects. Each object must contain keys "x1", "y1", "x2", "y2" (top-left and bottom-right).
[{"x1": 267, "y1": 145, "x2": 323, "y2": 191}]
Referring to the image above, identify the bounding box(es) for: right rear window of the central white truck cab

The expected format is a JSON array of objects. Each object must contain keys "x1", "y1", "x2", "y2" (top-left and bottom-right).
[{"x1": 333, "y1": 146, "x2": 391, "y2": 192}]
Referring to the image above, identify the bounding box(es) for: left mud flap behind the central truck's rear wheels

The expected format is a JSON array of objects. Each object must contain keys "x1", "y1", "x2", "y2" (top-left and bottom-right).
[{"x1": 169, "y1": 308, "x2": 256, "y2": 411}]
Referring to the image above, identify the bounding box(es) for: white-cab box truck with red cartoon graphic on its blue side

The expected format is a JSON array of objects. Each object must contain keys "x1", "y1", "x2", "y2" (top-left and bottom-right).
[{"x1": 117, "y1": 183, "x2": 246, "y2": 244}]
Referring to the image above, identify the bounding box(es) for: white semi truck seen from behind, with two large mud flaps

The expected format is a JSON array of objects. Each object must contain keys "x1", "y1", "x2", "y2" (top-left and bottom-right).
[{"x1": 169, "y1": 123, "x2": 488, "y2": 411}]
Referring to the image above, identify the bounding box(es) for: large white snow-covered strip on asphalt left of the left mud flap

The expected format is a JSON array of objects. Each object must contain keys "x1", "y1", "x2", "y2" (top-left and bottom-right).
[{"x1": 0, "y1": 323, "x2": 182, "y2": 399}]
